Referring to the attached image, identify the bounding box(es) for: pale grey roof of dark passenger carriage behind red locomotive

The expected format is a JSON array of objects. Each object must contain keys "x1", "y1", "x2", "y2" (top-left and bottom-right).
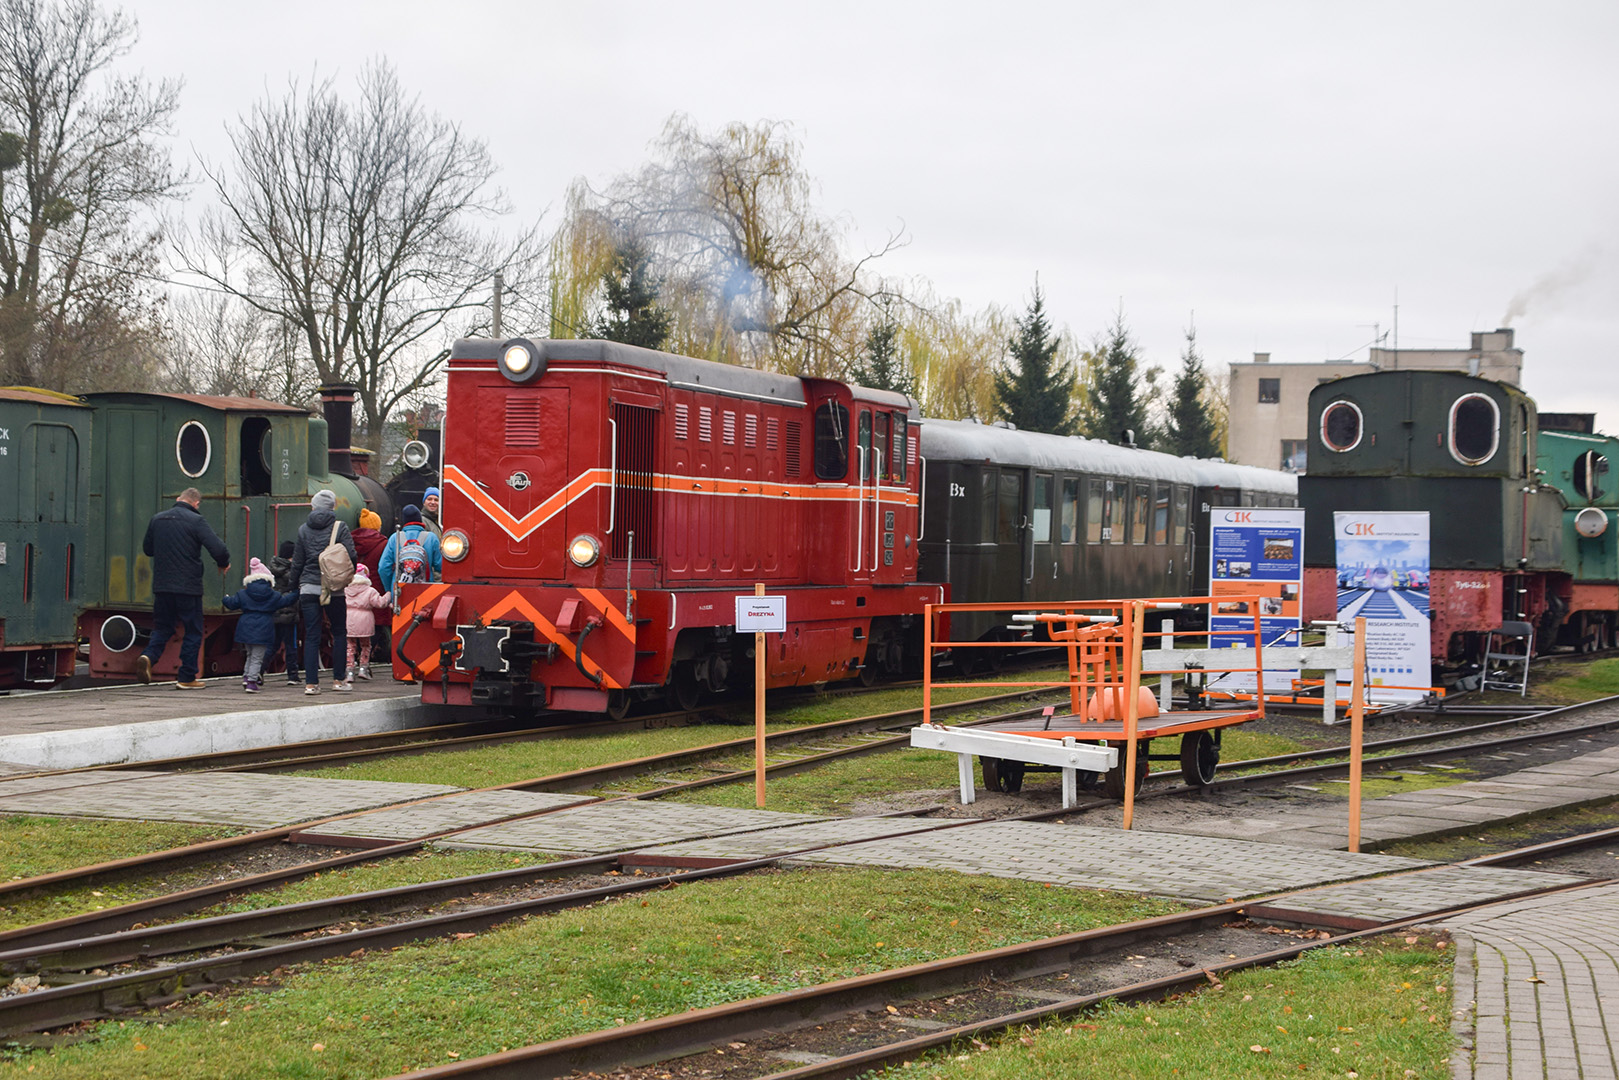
[{"x1": 921, "y1": 419, "x2": 1298, "y2": 494}]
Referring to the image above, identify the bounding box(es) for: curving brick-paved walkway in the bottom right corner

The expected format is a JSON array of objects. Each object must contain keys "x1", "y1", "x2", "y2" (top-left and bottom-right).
[{"x1": 1447, "y1": 882, "x2": 1619, "y2": 1080}]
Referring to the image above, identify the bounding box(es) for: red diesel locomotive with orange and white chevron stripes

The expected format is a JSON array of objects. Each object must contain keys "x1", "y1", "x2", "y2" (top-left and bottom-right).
[{"x1": 393, "y1": 338, "x2": 945, "y2": 714}]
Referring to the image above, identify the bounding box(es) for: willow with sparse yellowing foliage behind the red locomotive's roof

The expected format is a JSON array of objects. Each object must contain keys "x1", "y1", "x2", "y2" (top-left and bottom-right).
[{"x1": 552, "y1": 115, "x2": 900, "y2": 376}]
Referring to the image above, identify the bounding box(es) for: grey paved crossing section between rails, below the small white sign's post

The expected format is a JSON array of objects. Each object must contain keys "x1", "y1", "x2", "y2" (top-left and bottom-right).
[{"x1": 450, "y1": 800, "x2": 826, "y2": 857}]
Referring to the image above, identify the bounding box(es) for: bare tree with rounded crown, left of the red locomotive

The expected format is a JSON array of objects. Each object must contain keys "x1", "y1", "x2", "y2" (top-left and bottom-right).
[{"x1": 181, "y1": 62, "x2": 541, "y2": 449}]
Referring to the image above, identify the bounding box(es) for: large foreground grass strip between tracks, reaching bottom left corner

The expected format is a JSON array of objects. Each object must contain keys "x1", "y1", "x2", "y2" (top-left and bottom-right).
[{"x1": 5, "y1": 870, "x2": 1177, "y2": 1080}]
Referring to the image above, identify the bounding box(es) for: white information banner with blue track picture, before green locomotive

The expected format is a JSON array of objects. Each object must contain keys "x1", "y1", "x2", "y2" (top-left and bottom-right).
[{"x1": 1332, "y1": 510, "x2": 1433, "y2": 704}]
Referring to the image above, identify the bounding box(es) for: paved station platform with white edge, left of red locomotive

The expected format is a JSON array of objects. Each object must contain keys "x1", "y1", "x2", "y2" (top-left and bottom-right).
[{"x1": 0, "y1": 672, "x2": 430, "y2": 776}]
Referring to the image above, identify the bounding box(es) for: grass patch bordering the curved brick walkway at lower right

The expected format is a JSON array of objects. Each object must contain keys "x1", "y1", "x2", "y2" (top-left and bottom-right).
[{"x1": 882, "y1": 936, "x2": 1455, "y2": 1080}]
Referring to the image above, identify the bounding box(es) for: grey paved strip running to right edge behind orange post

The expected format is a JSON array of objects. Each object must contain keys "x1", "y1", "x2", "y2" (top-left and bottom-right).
[{"x1": 1137, "y1": 746, "x2": 1619, "y2": 848}]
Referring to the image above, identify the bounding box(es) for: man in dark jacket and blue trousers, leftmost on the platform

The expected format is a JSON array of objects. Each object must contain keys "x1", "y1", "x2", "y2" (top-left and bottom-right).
[{"x1": 134, "y1": 487, "x2": 230, "y2": 690}]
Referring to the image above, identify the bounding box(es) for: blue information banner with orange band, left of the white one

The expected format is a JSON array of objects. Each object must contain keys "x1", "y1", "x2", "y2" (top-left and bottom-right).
[{"x1": 1209, "y1": 507, "x2": 1305, "y2": 693}]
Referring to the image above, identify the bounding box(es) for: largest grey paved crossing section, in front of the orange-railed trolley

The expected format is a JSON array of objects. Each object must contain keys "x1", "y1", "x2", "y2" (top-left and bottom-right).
[{"x1": 780, "y1": 821, "x2": 1431, "y2": 902}]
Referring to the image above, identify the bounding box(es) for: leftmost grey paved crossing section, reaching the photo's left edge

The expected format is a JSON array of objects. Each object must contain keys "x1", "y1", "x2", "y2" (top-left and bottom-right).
[{"x1": 0, "y1": 772, "x2": 461, "y2": 829}]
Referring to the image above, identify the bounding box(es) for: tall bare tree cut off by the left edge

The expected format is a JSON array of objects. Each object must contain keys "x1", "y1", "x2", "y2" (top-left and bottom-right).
[{"x1": 0, "y1": 0, "x2": 181, "y2": 390}]
